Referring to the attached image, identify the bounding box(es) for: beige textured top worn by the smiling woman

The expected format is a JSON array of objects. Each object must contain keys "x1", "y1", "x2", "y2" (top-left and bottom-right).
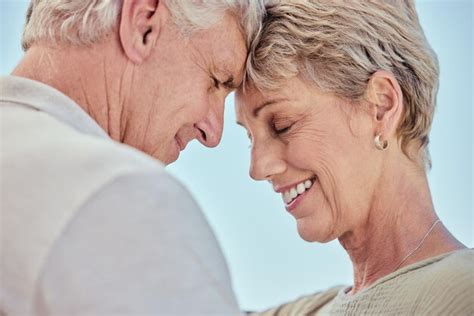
[{"x1": 255, "y1": 249, "x2": 474, "y2": 316}]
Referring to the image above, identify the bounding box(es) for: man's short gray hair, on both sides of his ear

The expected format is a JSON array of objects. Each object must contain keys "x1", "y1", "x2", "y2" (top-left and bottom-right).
[{"x1": 22, "y1": 0, "x2": 264, "y2": 51}]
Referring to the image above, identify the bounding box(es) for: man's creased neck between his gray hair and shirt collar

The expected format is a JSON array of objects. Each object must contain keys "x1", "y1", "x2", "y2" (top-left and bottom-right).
[{"x1": 12, "y1": 45, "x2": 130, "y2": 141}]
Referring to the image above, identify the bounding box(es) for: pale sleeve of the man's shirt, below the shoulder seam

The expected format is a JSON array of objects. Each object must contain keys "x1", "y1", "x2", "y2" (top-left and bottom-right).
[{"x1": 35, "y1": 173, "x2": 239, "y2": 315}]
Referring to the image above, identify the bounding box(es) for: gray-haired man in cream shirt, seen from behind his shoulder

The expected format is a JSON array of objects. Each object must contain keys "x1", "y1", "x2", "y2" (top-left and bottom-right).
[{"x1": 0, "y1": 0, "x2": 261, "y2": 315}]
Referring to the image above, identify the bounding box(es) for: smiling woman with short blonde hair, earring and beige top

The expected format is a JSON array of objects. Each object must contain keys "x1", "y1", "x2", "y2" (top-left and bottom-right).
[{"x1": 236, "y1": 0, "x2": 473, "y2": 315}]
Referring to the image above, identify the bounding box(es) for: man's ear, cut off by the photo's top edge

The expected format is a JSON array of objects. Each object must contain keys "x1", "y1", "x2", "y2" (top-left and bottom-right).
[{"x1": 119, "y1": 0, "x2": 162, "y2": 64}]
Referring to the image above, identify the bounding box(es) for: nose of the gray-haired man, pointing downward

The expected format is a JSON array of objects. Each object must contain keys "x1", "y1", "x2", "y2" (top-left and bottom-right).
[{"x1": 195, "y1": 102, "x2": 224, "y2": 147}]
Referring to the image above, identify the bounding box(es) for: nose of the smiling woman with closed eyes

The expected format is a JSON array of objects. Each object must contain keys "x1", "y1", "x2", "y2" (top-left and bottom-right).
[{"x1": 249, "y1": 144, "x2": 287, "y2": 180}]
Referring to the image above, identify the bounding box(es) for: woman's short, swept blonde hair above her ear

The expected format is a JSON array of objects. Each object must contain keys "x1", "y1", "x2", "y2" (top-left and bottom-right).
[{"x1": 246, "y1": 0, "x2": 439, "y2": 160}]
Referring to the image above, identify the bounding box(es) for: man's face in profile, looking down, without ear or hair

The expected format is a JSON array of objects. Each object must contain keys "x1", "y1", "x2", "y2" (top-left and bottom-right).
[{"x1": 123, "y1": 11, "x2": 247, "y2": 164}]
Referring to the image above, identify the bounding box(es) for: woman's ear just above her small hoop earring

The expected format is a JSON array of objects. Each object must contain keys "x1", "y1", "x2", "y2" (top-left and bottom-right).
[{"x1": 366, "y1": 70, "x2": 403, "y2": 138}]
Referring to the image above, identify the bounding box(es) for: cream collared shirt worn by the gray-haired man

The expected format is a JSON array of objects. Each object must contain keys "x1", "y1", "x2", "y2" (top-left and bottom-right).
[{"x1": 0, "y1": 76, "x2": 239, "y2": 315}]
